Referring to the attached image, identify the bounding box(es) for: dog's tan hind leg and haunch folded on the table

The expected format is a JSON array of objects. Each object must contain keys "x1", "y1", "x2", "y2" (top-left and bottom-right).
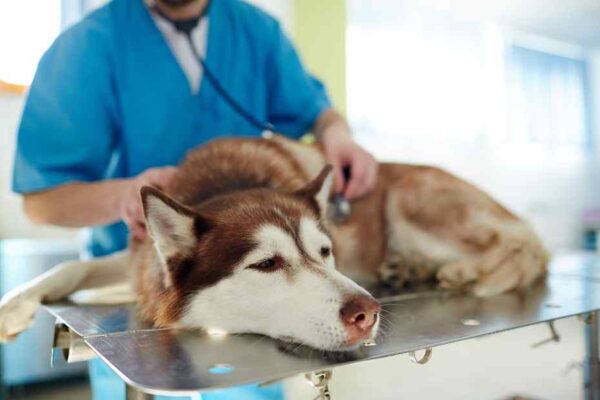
[{"x1": 387, "y1": 167, "x2": 548, "y2": 296}]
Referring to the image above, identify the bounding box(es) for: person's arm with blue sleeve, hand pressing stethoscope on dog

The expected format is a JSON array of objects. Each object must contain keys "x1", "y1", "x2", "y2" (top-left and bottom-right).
[{"x1": 264, "y1": 18, "x2": 377, "y2": 200}]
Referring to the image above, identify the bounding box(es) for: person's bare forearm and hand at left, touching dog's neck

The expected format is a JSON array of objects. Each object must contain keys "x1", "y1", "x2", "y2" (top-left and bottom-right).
[{"x1": 23, "y1": 167, "x2": 176, "y2": 239}]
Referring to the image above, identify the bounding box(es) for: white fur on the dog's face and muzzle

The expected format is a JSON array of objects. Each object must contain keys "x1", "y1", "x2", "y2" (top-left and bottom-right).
[{"x1": 181, "y1": 219, "x2": 377, "y2": 350}]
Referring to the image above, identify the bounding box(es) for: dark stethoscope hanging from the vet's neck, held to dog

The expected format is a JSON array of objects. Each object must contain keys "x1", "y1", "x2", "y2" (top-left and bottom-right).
[{"x1": 147, "y1": 0, "x2": 351, "y2": 223}]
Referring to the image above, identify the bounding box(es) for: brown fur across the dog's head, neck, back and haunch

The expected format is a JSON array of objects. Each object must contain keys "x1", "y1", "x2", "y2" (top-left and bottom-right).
[{"x1": 130, "y1": 137, "x2": 547, "y2": 326}]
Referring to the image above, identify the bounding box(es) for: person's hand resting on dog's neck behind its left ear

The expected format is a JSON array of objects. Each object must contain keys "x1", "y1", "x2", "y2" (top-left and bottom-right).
[{"x1": 121, "y1": 167, "x2": 177, "y2": 240}]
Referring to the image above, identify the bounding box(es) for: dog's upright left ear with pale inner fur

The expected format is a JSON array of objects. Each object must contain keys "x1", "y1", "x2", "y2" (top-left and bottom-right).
[{"x1": 140, "y1": 186, "x2": 210, "y2": 286}]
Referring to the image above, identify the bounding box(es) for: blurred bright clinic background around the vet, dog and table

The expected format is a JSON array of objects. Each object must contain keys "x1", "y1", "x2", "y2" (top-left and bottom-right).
[{"x1": 0, "y1": 0, "x2": 600, "y2": 399}]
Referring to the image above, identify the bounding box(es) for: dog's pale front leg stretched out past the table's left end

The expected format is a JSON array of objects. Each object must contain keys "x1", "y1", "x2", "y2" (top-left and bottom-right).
[{"x1": 0, "y1": 251, "x2": 129, "y2": 341}]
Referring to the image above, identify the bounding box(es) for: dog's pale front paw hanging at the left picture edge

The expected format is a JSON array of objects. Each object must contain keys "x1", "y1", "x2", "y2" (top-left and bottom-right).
[{"x1": 0, "y1": 294, "x2": 40, "y2": 343}]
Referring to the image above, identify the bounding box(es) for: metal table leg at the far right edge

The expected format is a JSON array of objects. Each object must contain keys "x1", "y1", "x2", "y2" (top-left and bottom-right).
[{"x1": 583, "y1": 311, "x2": 600, "y2": 400}]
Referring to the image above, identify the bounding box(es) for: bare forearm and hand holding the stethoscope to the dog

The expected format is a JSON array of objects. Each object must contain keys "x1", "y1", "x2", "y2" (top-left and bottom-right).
[{"x1": 313, "y1": 108, "x2": 377, "y2": 200}]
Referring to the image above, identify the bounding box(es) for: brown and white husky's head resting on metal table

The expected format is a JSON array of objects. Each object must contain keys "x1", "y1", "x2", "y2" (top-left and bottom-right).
[{"x1": 142, "y1": 167, "x2": 379, "y2": 350}]
